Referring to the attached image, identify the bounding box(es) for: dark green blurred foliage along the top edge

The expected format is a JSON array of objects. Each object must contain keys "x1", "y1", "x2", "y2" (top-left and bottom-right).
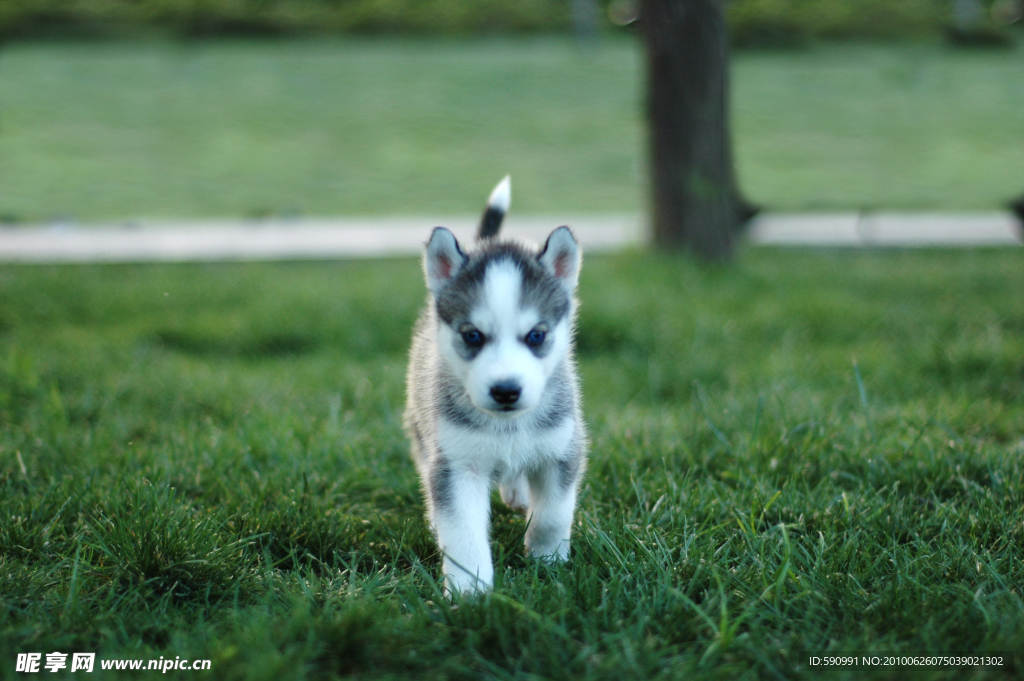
[{"x1": 0, "y1": 0, "x2": 1021, "y2": 47}]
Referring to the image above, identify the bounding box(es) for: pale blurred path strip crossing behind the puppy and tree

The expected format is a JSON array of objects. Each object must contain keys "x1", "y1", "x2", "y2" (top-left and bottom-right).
[{"x1": 0, "y1": 212, "x2": 1021, "y2": 262}]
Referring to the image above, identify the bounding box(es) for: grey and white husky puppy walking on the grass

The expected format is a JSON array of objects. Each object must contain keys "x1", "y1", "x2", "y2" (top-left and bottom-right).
[{"x1": 404, "y1": 177, "x2": 587, "y2": 593}]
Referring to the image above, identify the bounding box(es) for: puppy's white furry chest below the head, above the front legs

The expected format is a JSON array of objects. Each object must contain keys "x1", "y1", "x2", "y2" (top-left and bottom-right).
[{"x1": 437, "y1": 411, "x2": 575, "y2": 476}]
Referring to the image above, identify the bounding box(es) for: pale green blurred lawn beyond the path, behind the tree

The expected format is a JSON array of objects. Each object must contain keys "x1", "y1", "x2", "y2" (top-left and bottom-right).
[{"x1": 0, "y1": 38, "x2": 1024, "y2": 221}]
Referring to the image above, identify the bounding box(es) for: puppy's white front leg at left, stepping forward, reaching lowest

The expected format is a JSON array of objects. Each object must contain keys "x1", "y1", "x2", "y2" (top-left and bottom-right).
[{"x1": 429, "y1": 461, "x2": 495, "y2": 593}]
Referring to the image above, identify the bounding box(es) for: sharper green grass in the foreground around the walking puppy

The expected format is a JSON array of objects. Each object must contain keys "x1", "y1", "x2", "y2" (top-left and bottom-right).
[{"x1": 0, "y1": 250, "x2": 1024, "y2": 679}]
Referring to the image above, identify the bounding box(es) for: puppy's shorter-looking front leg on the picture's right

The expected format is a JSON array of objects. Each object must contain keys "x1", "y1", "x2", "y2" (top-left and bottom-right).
[{"x1": 526, "y1": 461, "x2": 580, "y2": 560}]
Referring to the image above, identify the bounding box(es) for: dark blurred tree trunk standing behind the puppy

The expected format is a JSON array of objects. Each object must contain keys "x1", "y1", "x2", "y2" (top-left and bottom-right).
[{"x1": 640, "y1": 0, "x2": 757, "y2": 260}]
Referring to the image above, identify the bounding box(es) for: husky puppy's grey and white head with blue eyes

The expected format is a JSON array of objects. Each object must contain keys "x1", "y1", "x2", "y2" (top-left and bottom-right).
[{"x1": 424, "y1": 227, "x2": 581, "y2": 417}]
